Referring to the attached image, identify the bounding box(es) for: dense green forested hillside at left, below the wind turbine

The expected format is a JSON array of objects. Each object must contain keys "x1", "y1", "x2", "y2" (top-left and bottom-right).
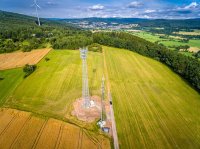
[{"x1": 0, "y1": 11, "x2": 92, "y2": 53}]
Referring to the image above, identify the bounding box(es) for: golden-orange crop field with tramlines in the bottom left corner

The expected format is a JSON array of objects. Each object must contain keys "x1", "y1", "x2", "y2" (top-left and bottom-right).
[{"x1": 0, "y1": 109, "x2": 110, "y2": 149}]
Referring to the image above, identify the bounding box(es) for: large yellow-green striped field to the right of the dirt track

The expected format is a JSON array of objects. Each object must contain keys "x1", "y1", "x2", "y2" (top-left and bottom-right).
[{"x1": 104, "y1": 47, "x2": 200, "y2": 149}]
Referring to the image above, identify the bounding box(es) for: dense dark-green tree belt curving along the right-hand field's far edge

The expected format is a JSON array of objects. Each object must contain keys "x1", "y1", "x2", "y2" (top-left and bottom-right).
[{"x1": 93, "y1": 32, "x2": 200, "y2": 90}]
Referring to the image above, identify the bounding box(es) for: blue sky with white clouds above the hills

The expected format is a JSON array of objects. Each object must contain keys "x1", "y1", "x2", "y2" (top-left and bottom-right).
[{"x1": 0, "y1": 0, "x2": 200, "y2": 19}]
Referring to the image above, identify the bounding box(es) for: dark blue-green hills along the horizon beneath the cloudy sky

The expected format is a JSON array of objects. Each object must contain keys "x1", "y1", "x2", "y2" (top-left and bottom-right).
[{"x1": 0, "y1": 10, "x2": 200, "y2": 29}]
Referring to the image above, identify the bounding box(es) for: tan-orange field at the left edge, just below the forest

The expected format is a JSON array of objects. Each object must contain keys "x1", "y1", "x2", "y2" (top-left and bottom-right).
[{"x1": 0, "y1": 49, "x2": 51, "y2": 70}]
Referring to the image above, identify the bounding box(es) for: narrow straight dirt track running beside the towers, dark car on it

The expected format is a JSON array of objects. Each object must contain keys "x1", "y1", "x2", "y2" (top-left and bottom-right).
[{"x1": 103, "y1": 50, "x2": 119, "y2": 149}]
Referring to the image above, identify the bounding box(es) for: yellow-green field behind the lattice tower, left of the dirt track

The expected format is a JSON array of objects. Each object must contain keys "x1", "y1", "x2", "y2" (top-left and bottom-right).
[{"x1": 3, "y1": 50, "x2": 103, "y2": 123}]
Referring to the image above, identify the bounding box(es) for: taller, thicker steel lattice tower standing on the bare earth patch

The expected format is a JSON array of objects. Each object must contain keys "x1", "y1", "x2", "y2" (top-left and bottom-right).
[{"x1": 80, "y1": 48, "x2": 90, "y2": 108}]
